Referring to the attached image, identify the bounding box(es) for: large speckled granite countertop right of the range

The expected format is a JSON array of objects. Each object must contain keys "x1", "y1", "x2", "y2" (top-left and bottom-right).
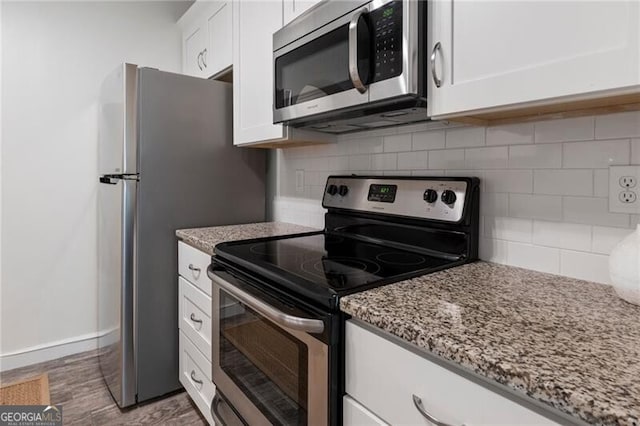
[{"x1": 340, "y1": 262, "x2": 640, "y2": 426}]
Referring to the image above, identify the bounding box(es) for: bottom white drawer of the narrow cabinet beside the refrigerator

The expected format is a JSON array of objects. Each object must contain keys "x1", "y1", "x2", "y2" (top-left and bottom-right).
[{"x1": 180, "y1": 331, "x2": 216, "y2": 425}]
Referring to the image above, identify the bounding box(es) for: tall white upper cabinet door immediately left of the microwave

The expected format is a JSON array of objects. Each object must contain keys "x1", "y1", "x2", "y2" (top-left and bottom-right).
[{"x1": 232, "y1": 0, "x2": 284, "y2": 145}]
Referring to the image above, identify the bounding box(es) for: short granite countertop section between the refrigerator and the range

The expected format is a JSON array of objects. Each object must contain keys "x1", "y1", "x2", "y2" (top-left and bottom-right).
[{"x1": 176, "y1": 222, "x2": 319, "y2": 256}]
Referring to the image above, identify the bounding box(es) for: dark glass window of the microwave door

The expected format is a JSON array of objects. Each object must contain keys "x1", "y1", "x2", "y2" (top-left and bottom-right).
[{"x1": 275, "y1": 17, "x2": 371, "y2": 109}]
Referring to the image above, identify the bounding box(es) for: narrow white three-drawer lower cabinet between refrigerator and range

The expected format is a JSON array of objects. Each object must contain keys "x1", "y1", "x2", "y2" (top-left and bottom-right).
[{"x1": 178, "y1": 242, "x2": 216, "y2": 424}]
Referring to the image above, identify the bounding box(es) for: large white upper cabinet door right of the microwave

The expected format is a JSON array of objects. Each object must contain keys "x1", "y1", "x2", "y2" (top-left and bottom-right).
[{"x1": 429, "y1": 0, "x2": 640, "y2": 117}]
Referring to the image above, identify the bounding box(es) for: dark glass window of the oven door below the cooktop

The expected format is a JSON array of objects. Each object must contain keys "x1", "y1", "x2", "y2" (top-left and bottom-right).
[{"x1": 218, "y1": 290, "x2": 309, "y2": 425}]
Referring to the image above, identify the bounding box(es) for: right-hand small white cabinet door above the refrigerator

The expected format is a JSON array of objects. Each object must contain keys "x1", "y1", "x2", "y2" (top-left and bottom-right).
[{"x1": 204, "y1": 1, "x2": 232, "y2": 76}]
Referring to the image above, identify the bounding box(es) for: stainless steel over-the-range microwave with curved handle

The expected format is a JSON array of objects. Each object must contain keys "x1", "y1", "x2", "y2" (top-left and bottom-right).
[{"x1": 273, "y1": 0, "x2": 428, "y2": 133}]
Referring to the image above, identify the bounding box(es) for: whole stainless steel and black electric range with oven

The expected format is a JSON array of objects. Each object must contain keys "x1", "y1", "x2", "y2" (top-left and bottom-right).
[{"x1": 208, "y1": 176, "x2": 479, "y2": 425}]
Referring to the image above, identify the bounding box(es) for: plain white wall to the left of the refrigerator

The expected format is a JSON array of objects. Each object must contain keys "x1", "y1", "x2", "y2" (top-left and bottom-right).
[{"x1": 0, "y1": 2, "x2": 188, "y2": 369}]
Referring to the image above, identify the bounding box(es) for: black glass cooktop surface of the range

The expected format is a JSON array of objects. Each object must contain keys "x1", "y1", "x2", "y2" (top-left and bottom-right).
[{"x1": 216, "y1": 233, "x2": 453, "y2": 304}]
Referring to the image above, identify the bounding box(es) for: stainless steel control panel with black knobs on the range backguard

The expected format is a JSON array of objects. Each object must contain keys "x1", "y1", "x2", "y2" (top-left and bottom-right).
[{"x1": 322, "y1": 176, "x2": 469, "y2": 222}]
